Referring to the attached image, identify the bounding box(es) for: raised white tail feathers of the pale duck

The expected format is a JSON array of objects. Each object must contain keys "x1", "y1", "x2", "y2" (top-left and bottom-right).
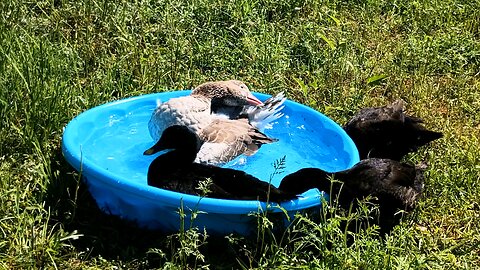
[{"x1": 242, "y1": 92, "x2": 287, "y2": 130}]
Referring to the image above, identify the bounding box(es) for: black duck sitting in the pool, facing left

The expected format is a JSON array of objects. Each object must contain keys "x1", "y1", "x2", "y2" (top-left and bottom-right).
[{"x1": 144, "y1": 125, "x2": 297, "y2": 202}]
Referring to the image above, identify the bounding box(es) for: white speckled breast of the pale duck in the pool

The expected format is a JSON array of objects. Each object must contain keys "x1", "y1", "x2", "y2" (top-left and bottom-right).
[{"x1": 148, "y1": 96, "x2": 212, "y2": 141}]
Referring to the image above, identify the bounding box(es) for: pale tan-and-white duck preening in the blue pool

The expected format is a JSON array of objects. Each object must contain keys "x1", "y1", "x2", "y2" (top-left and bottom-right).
[{"x1": 149, "y1": 80, "x2": 286, "y2": 165}]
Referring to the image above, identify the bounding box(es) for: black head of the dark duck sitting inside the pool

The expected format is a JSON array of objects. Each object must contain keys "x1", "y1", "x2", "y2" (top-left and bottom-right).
[{"x1": 143, "y1": 125, "x2": 202, "y2": 155}]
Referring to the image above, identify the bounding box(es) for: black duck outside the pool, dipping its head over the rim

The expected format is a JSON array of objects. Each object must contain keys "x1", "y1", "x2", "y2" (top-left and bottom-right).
[{"x1": 279, "y1": 158, "x2": 425, "y2": 232}]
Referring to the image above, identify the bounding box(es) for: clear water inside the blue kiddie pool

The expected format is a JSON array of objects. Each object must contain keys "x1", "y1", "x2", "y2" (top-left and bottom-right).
[{"x1": 82, "y1": 98, "x2": 350, "y2": 189}]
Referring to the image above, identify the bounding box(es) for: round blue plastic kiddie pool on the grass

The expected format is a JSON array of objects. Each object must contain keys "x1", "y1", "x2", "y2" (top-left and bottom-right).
[{"x1": 62, "y1": 91, "x2": 359, "y2": 235}]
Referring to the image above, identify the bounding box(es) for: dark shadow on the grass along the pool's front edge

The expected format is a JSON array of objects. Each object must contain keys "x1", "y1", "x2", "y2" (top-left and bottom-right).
[{"x1": 46, "y1": 146, "x2": 408, "y2": 269}]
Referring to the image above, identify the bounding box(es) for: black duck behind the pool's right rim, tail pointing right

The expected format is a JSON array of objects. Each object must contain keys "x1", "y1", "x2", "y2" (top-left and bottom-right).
[{"x1": 344, "y1": 100, "x2": 442, "y2": 160}]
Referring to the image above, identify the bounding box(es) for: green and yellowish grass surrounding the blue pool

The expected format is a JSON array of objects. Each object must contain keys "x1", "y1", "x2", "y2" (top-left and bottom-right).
[{"x1": 0, "y1": 0, "x2": 480, "y2": 269}]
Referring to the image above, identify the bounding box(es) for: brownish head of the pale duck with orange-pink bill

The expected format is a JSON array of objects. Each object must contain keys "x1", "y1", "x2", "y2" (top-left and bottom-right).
[{"x1": 192, "y1": 80, "x2": 263, "y2": 106}]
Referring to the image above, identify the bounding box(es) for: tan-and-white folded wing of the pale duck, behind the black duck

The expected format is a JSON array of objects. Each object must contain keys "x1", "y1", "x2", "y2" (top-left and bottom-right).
[{"x1": 196, "y1": 119, "x2": 277, "y2": 164}]
